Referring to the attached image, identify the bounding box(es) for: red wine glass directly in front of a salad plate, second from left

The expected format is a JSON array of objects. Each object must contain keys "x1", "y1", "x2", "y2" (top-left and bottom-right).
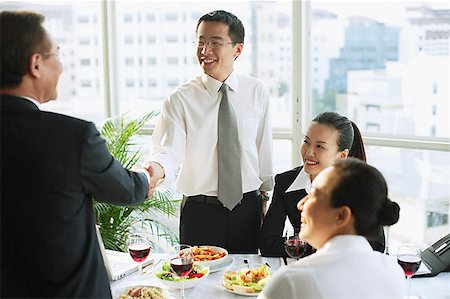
[{"x1": 170, "y1": 244, "x2": 194, "y2": 299}]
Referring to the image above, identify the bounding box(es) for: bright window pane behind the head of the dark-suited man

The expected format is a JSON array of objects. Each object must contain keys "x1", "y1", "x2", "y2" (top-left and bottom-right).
[{"x1": 0, "y1": 1, "x2": 105, "y2": 124}]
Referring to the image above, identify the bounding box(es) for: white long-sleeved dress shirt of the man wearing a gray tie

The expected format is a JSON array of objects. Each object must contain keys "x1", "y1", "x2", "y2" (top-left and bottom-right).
[{"x1": 152, "y1": 71, "x2": 273, "y2": 196}]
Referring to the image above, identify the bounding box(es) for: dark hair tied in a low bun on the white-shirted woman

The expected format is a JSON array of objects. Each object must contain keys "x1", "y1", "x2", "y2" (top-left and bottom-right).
[{"x1": 330, "y1": 158, "x2": 400, "y2": 238}]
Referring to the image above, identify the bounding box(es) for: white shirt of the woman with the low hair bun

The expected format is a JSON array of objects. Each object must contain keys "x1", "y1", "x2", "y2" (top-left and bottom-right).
[{"x1": 258, "y1": 235, "x2": 405, "y2": 299}]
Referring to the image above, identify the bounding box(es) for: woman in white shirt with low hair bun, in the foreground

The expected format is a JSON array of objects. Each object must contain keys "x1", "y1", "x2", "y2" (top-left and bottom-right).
[{"x1": 259, "y1": 158, "x2": 405, "y2": 298}]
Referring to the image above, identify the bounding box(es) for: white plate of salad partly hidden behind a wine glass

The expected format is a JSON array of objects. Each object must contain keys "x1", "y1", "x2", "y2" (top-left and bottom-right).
[{"x1": 154, "y1": 261, "x2": 209, "y2": 289}]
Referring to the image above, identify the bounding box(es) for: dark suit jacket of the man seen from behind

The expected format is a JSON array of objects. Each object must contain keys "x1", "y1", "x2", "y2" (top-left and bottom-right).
[{"x1": 0, "y1": 95, "x2": 149, "y2": 298}]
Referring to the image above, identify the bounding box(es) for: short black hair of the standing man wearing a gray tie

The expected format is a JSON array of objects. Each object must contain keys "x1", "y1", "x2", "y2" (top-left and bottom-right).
[{"x1": 195, "y1": 10, "x2": 245, "y2": 44}]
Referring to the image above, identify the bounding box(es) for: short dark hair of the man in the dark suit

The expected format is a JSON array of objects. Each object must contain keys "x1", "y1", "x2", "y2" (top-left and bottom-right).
[{"x1": 0, "y1": 11, "x2": 50, "y2": 88}]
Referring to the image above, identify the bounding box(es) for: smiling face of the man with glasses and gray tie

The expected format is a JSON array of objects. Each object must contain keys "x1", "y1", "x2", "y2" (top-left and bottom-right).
[{"x1": 197, "y1": 21, "x2": 243, "y2": 82}]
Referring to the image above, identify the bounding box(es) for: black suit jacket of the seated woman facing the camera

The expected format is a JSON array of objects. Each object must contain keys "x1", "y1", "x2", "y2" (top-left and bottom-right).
[{"x1": 260, "y1": 166, "x2": 385, "y2": 257}]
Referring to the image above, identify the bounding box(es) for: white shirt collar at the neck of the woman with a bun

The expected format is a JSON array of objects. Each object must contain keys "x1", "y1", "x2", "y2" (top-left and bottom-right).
[{"x1": 317, "y1": 235, "x2": 373, "y2": 253}]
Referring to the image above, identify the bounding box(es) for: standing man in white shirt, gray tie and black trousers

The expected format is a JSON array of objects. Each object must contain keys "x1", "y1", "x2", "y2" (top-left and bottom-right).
[{"x1": 147, "y1": 10, "x2": 273, "y2": 253}]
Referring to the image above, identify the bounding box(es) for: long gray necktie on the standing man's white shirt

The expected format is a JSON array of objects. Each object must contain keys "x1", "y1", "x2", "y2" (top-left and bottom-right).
[{"x1": 217, "y1": 84, "x2": 242, "y2": 211}]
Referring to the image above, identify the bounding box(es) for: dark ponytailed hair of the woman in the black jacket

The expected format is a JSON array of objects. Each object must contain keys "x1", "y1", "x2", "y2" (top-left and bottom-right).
[{"x1": 313, "y1": 112, "x2": 367, "y2": 161}]
